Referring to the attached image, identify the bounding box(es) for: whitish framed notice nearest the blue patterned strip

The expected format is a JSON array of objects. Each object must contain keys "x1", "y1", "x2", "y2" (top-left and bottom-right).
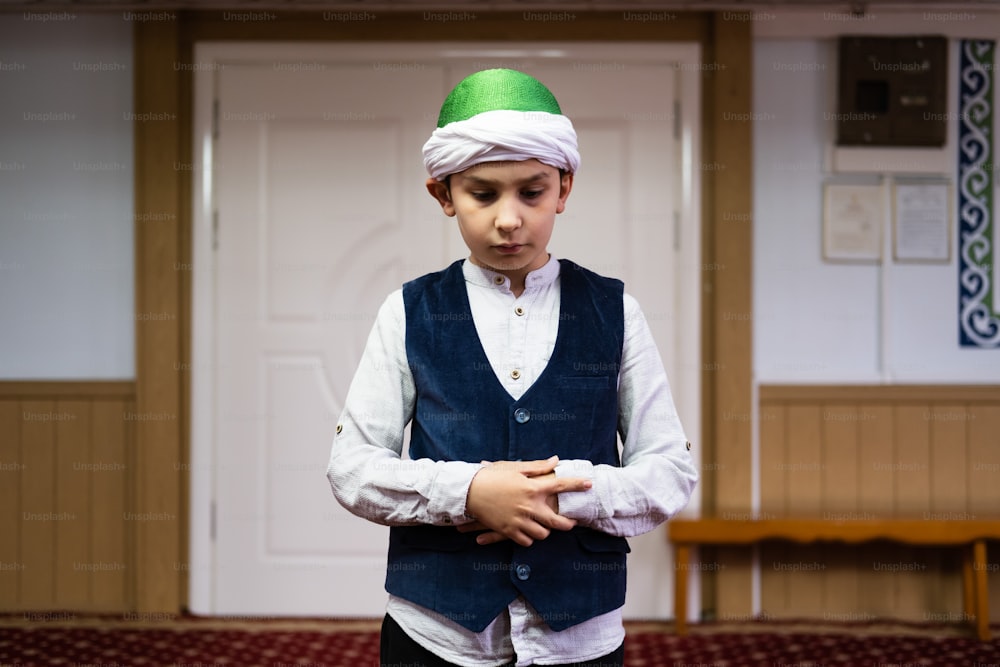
[{"x1": 892, "y1": 179, "x2": 951, "y2": 262}]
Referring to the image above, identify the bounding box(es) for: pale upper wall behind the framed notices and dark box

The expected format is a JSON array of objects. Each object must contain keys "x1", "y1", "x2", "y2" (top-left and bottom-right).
[{"x1": 752, "y1": 13, "x2": 1000, "y2": 384}]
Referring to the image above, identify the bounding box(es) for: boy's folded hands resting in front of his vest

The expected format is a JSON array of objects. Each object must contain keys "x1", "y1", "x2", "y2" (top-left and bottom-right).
[{"x1": 459, "y1": 456, "x2": 592, "y2": 547}]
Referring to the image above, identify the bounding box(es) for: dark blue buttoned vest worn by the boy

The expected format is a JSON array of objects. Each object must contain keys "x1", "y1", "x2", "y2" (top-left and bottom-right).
[{"x1": 386, "y1": 260, "x2": 629, "y2": 632}]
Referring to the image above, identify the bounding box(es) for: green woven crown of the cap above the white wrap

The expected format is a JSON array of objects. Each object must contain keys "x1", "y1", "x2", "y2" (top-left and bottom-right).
[{"x1": 438, "y1": 69, "x2": 562, "y2": 127}]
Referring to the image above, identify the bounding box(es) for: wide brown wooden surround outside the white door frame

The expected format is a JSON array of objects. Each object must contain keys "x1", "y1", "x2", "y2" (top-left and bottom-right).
[{"x1": 134, "y1": 10, "x2": 753, "y2": 614}]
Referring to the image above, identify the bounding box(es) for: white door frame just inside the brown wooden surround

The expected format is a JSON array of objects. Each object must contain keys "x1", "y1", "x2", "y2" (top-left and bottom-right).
[{"x1": 188, "y1": 42, "x2": 701, "y2": 614}]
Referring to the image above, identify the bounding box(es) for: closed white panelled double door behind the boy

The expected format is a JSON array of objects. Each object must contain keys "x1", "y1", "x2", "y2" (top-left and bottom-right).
[{"x1": 191, "y1": 45, "x2": 699, "y2": 618}]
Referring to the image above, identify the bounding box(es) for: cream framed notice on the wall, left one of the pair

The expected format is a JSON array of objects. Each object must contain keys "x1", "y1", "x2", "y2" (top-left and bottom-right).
[{"x1": 823, "y1": 183, "x2": 884, "y2": 262}]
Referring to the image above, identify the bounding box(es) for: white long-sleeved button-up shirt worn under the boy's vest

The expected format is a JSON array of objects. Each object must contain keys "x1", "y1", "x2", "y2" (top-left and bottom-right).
[{"x1": 327, "y1": 258, "x2": 698, "y2": 667}]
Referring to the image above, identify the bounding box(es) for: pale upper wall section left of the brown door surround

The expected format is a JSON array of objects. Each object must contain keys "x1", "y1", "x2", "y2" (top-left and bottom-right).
[{"x1": 0, "y1": 11, "x2": 135, "y2": 380}]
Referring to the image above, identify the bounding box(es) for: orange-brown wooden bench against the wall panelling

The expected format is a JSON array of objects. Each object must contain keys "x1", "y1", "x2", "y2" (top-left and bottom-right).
[{"x1": 668, "y1": 519, "x2": 1000, "y2": 641}]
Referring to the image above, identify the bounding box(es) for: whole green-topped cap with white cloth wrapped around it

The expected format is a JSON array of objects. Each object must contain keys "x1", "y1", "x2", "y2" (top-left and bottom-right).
[{"x1": 424, "y1": 69, "x2": 580, "y2": 181}]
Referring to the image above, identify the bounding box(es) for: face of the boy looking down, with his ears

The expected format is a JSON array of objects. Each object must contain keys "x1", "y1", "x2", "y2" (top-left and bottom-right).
[{"x1": 427, "y1": 160, "x2": 573, "y2": 280}]
